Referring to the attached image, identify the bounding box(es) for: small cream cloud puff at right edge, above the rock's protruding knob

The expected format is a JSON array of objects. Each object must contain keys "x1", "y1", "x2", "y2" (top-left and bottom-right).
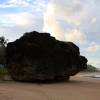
[{"x1": 86, "y1": 42, "x2": 100, "y2": 53}]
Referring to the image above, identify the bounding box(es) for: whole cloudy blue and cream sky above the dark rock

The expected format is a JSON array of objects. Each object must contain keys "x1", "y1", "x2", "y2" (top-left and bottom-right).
[{"x1": 0, "y1": 0, "x2": 100, "y2": 68}]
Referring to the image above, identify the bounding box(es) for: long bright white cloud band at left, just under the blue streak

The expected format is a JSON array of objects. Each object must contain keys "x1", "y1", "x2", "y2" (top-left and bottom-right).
[{"x1": 0, "y1": 12, "x2": 43, "y2": 27}]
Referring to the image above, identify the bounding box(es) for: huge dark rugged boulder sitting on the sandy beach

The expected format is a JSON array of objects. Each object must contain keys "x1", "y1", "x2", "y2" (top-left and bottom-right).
[{"x1": 6, "y1": 31, "x2": 87, "y2": 81}]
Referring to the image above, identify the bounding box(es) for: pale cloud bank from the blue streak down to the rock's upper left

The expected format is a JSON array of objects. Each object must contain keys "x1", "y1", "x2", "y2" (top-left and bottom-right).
[{"x1": 0, "y1": 12, "x2": 43, "y2": 41}]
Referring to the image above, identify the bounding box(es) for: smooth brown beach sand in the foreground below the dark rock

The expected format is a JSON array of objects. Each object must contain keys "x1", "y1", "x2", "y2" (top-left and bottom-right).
[{"x1": 0, "y1": 75, "x2": 100, "y2": 100}]
